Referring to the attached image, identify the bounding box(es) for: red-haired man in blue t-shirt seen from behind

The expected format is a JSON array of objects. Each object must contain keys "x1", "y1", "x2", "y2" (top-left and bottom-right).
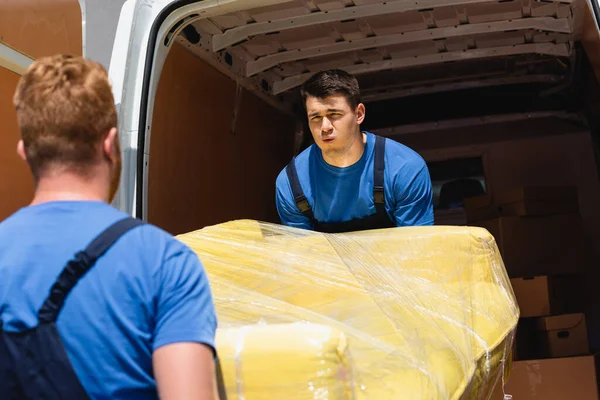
[{"x1": 0, "y1": 56, "x2": 217, "y2": 400}]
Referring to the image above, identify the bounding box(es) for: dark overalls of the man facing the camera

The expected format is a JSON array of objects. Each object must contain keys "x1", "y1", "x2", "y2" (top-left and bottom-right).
[{"x1": 285, "y1": 135, "x2": 396, "y2": 233}]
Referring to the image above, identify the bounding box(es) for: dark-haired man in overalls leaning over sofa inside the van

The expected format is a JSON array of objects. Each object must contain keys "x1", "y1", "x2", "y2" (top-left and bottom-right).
[{"x1": 276, "y1": 70, "x2": 433, "y2": 233}]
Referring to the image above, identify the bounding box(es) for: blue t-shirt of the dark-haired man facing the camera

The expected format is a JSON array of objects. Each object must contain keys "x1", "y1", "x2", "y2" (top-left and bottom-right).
[{"x1": 276, "y1": 132, "x2": 433, "y2": 229}]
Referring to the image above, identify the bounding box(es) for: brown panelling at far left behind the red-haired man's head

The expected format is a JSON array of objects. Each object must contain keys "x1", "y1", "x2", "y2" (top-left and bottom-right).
[{"x1": 0, "y1": 0, "x2": 82, "y2": 221}]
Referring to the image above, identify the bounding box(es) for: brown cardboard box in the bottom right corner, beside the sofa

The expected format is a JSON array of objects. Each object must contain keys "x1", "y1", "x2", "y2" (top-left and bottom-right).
[{"x1": 491, "y1": 355, "x2": 598, "y2": 400}]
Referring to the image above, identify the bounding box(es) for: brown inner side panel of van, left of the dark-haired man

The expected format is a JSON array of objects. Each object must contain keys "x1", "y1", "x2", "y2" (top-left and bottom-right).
[{"x1": 148, "y1": 44, "x2": 295, "y2": 234}]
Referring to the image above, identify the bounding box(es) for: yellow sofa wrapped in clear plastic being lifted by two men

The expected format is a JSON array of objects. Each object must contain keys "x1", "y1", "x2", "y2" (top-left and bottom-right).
[{"x1": 178, "y1": 220, "x2": 519, "y2": 400}]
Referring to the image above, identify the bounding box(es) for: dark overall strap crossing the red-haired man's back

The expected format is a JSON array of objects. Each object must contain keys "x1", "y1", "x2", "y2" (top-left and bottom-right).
[{"x1": 38, "y1": 217, "x2": 144, "y2": 323}]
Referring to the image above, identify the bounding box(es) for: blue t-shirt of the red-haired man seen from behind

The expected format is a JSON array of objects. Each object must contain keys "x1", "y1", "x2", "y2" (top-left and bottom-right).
[{"x1": 0, "y1": 201, "x2": 217, "y2": 399}]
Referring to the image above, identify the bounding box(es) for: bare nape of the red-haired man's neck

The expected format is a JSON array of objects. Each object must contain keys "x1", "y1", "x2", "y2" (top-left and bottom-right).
[{"x1": 31, "y1": 172, "x2": 108, "y2": 205}]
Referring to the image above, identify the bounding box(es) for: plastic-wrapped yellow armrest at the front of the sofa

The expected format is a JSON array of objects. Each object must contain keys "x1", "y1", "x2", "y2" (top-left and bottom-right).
[{"x1": 216, "y1": 323, "x2": 353, "y2": 400}]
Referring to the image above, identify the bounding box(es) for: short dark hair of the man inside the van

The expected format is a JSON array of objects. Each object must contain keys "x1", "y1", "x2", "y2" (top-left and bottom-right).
[{"x1": 300, "y1": 69, "x2": 360, "y2": 109}]
